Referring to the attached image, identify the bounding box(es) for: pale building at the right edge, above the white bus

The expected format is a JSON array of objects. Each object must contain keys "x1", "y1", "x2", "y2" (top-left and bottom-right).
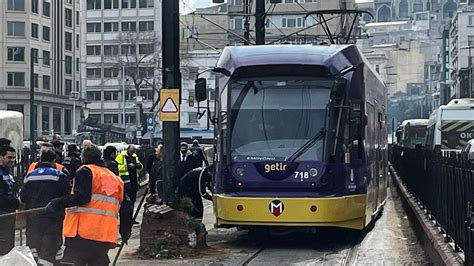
[{"x1": 449, "y1": 5, "x2": 474, "y2": 98}]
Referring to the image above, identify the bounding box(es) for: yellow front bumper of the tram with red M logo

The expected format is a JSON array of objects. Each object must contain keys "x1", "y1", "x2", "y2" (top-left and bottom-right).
[{"x1": 214, "y1": 194, "x2": 367, "y2": 229}]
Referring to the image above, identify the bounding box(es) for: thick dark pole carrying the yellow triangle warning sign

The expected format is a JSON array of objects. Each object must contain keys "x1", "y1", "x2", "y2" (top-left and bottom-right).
[{"x1": 161, "y1": 1, "x2": 181, "y2": 204}]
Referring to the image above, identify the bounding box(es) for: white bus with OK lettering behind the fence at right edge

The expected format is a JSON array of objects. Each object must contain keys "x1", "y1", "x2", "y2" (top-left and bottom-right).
[{"x1": 425, "y1": 98, "x2": 474, "y2": 152}]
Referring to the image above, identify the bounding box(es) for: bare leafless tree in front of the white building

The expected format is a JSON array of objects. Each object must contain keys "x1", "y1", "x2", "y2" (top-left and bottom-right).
[{"x1": 115, "y1": 29, "x2": 161, "y2": 133}]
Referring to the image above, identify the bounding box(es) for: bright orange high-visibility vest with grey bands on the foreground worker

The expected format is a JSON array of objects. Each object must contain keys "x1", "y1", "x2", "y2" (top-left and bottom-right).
[{"x1": 63, "y1": 164, "x2": 124, "y2": 244}]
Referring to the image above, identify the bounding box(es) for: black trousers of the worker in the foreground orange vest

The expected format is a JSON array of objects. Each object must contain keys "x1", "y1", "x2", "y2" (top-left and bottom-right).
[{"x1": 61, "y1": 246, "x2": 110, "y2": 266}]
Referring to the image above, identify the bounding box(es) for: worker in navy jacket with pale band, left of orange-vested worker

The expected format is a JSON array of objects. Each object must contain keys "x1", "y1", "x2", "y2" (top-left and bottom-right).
[{"x1": 20, "y1": 150, "x2": 71, "y2": 265}]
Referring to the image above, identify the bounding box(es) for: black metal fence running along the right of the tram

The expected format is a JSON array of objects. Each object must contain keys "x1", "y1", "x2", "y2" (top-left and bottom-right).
[{"x1": 392, "y1": 146, "x2": 474, "y2": 265}]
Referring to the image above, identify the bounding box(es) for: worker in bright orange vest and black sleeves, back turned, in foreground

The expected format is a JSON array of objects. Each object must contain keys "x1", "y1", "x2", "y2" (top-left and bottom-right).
[{"x1": 46, "y1": 146, "x2": 133, "y2": 265}]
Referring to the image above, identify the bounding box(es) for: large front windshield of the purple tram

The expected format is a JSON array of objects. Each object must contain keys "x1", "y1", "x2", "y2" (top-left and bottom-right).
[{"x1": 229, "y1": 77, "x2": 334, "y2": 161}]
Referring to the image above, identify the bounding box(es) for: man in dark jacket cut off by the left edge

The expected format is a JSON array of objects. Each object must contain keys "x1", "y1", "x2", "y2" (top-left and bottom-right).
[{"x1": 0, "y1": 145, "x2": 20, "y2": 256}]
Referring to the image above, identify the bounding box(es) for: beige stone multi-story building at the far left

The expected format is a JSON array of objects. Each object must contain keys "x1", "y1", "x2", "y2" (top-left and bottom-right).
[{"x1": 0, "y1": 0, "x2": 81, "y2": 139}]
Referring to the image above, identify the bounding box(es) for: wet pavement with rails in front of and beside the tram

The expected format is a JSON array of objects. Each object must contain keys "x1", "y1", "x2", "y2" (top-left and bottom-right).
[{"x1": 109, "y1": 178, "x2": 430, "y2": 265}]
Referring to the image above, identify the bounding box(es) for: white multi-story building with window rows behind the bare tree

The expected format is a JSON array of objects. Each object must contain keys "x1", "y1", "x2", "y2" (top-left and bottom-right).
[{"x1": 81, "y1": 0, "x2": 161, "y2": 139}]
